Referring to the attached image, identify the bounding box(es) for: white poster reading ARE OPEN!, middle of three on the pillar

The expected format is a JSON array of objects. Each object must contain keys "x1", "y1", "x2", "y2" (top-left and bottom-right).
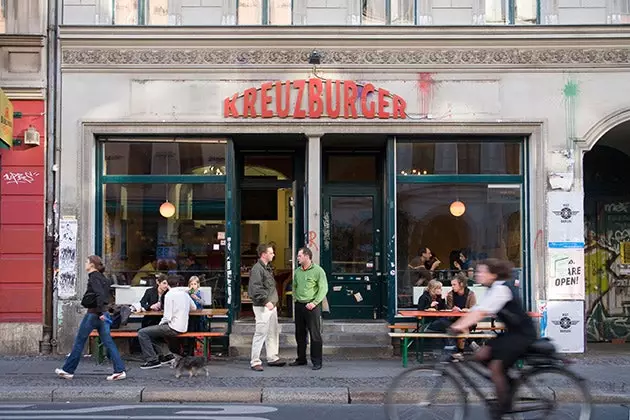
[{"x1": 547, "y1": 248, "x2": 586, "y2": 300}]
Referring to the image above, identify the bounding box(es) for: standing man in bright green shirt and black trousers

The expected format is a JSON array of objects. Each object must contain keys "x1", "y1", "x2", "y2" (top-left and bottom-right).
[{"x1": 289, "y1": 247, "x2": 328, "y2": 370}]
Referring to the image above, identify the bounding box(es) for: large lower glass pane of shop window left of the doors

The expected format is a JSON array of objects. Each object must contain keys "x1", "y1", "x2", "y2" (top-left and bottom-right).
[{"x1": 102, "y1": 184, "x2": 230, "y2": 305}]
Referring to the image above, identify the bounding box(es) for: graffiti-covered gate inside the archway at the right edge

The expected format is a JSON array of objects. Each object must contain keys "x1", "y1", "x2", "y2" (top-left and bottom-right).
[{"x1": 584, "y1": 202, "x2": 630, "y2": 341}]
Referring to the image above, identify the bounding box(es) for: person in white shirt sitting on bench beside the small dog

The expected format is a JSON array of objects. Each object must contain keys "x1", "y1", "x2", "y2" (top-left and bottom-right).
[{"x1": 138, "y1": 276, "x2": 197, "y2": 369}]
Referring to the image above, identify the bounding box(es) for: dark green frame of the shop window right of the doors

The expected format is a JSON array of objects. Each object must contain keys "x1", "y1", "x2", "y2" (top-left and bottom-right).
[{"x1": 396, "y1": 137, "x2": 533, "y2": 311}]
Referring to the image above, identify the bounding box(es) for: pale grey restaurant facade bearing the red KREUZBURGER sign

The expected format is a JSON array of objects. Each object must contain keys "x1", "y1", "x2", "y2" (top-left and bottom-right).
[{"x1": 54, "y1": 0, "x2": 630, "y2": 351}]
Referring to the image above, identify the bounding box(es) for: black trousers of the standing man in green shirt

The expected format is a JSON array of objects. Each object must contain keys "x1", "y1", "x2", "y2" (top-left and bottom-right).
[{"x1": 295, "y1": 302, "x2": 323, "y2": 365}]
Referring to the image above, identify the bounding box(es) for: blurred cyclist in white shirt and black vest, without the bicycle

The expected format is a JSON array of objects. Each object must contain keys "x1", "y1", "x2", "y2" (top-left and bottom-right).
[{"x1": 450, "y1": 258, "x2": 537, "y2": 419}]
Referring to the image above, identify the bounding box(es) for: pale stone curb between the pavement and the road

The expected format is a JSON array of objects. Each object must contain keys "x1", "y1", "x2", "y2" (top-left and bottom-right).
[{"x1": 0, "y1": 386, "x2": 630, "y2": 405}]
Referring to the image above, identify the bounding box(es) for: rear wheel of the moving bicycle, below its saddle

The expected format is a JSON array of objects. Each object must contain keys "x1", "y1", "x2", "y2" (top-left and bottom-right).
[{"x1": 512, "y1": 366, "x2": 592, "y2": 420}]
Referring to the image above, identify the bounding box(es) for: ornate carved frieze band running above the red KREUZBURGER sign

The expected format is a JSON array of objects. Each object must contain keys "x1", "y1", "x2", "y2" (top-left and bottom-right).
[{"x1": 63, "y1": 48, "x2": 630, "y2": 68}]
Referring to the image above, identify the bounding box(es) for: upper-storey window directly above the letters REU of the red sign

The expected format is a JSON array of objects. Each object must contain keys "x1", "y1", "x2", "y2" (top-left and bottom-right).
[{"x1": 238, "y1": 0, "x2": 292, "y2": 25}]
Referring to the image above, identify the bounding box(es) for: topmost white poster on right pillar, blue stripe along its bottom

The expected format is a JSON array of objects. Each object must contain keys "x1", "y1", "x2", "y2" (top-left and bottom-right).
[{"x1": 547, "y1": 191, "x2": 584, "y2": 248}]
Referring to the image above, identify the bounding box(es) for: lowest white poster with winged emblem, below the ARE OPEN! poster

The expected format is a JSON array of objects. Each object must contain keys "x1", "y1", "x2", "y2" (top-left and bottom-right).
[{"x1": 541, "y1": 300, "x2": 585, "y2": 353}]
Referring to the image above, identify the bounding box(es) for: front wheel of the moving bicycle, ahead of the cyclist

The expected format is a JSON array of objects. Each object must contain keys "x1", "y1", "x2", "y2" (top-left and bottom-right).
[{"x1": 385, "y1": 366, "x2": 467, "y2": 420}]
